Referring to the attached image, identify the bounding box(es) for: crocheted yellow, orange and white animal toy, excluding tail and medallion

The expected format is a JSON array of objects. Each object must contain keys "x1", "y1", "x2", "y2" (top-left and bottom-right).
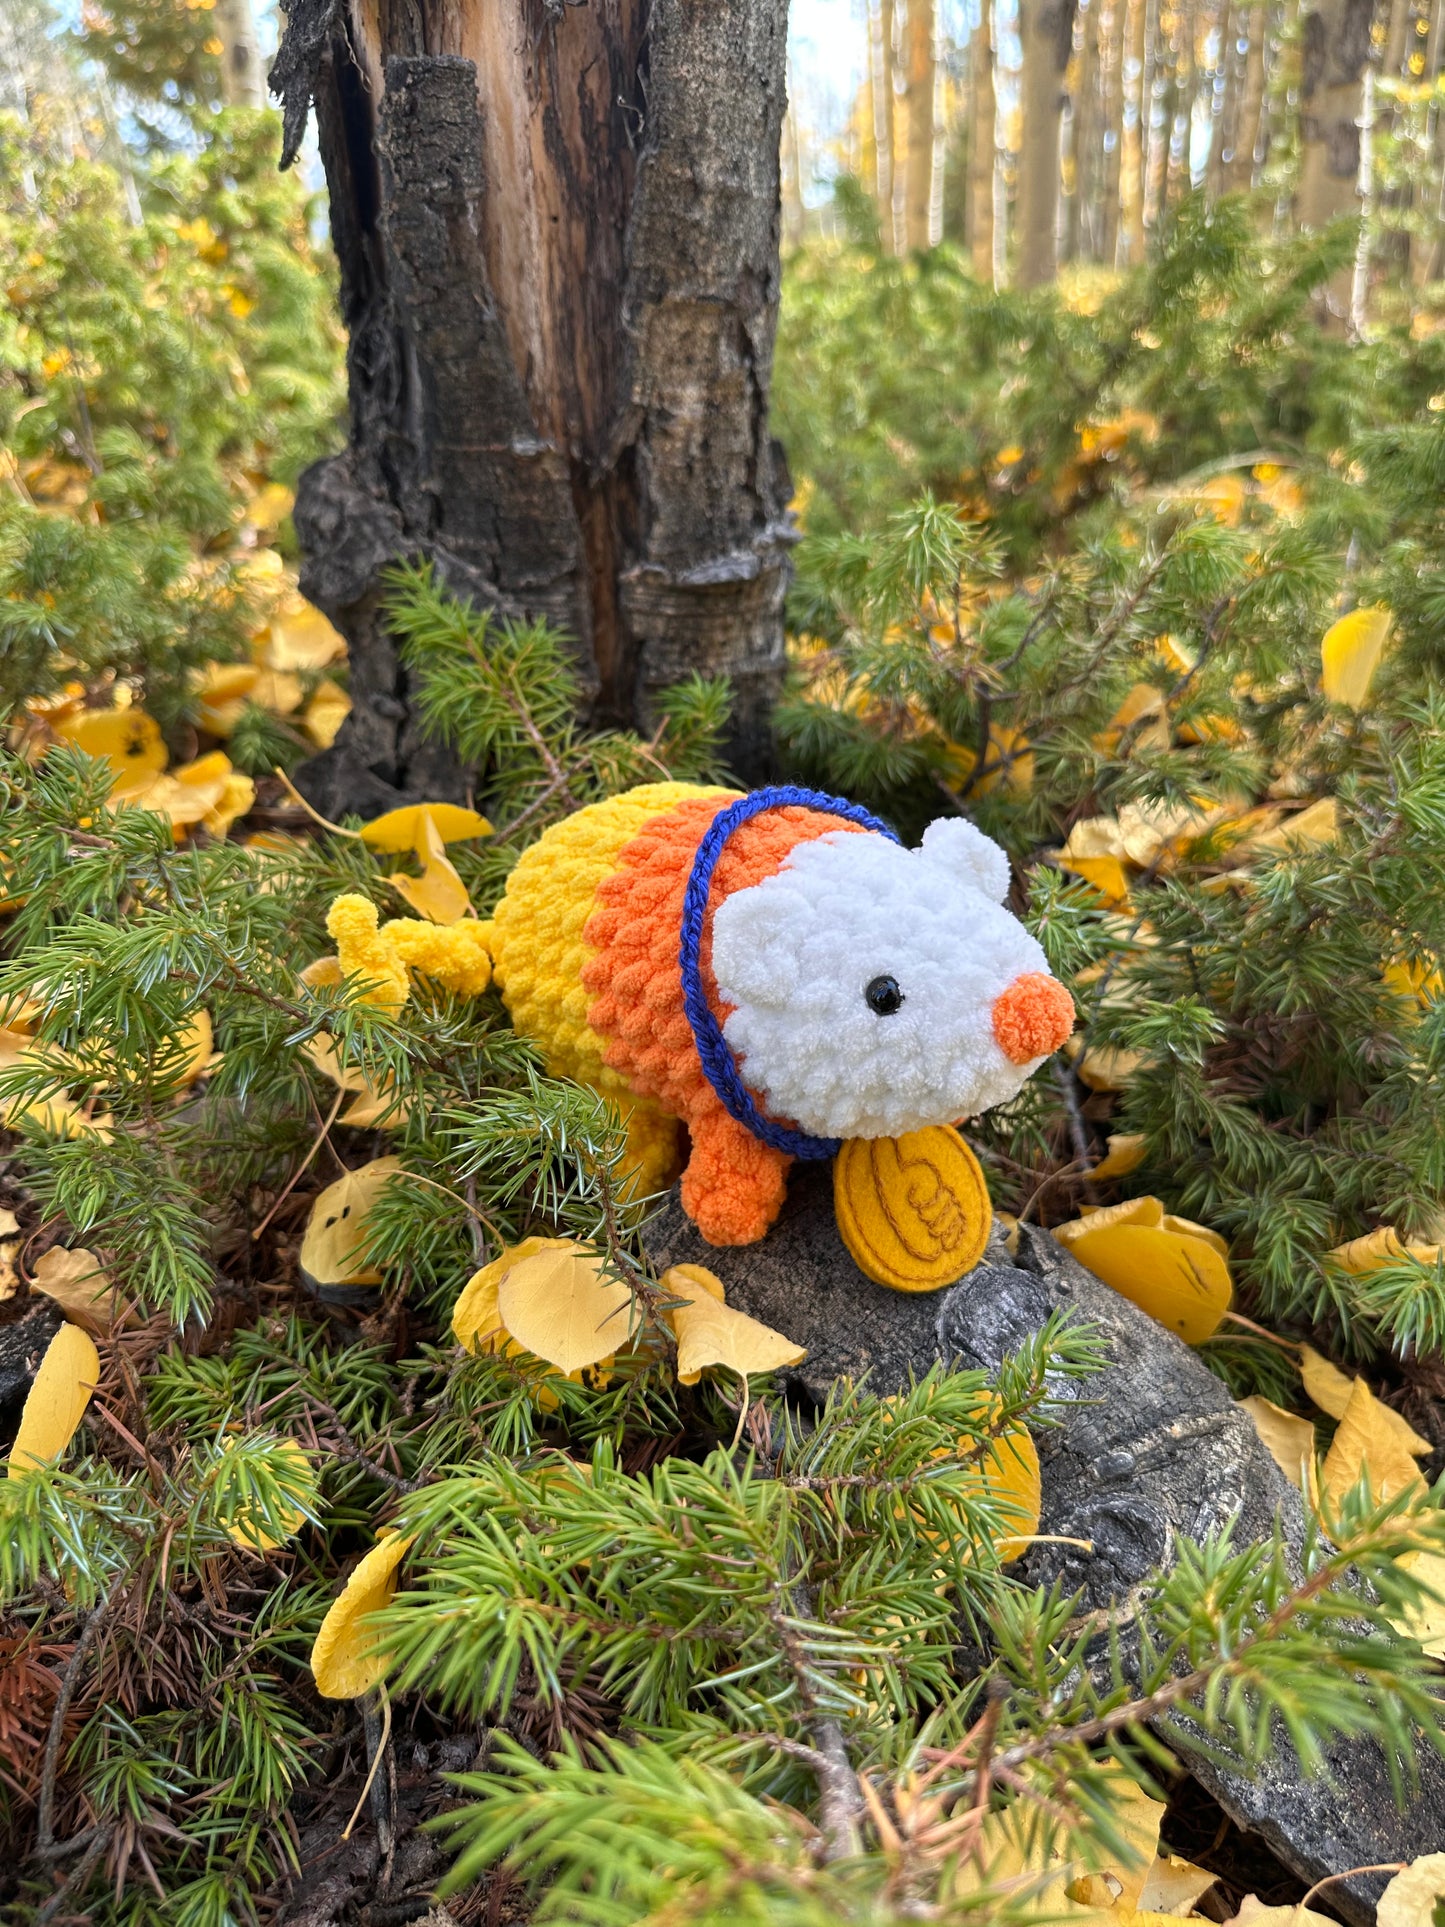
[{"x1": 466, "y1": 782, "x2": 1073, "y2": 1245}]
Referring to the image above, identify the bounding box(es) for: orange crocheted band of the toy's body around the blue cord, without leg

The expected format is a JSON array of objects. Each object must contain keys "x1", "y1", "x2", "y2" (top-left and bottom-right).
[{"x1": 582, "y1": 796, "x2": 867, "y2": 1122}]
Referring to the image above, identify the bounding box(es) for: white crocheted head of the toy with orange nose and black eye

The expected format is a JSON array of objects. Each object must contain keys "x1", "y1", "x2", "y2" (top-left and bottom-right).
[{"x1": 713, "y1": 817, "x2": 1073, "y2": 1137}]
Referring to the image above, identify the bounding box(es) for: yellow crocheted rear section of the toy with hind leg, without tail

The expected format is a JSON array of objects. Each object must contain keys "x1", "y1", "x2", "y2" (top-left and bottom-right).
[{"x1": 486, "y1": 782, "x2": 738, "y2": 1191}]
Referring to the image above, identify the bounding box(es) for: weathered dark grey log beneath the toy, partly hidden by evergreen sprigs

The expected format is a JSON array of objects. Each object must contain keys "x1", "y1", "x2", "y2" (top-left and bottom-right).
[{"x1": 647, "y1": 1168, "x2": 1445, "y2": 1927}]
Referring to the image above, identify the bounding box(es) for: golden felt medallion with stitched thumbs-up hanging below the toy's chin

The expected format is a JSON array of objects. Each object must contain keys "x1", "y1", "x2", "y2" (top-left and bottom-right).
[{"x1": 832, "y1": 1125, "x2": 994, "y2": 1291}]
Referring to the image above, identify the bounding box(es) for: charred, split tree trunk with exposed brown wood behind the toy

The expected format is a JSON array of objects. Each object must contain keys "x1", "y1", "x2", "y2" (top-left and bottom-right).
[{"x1": 272, "y1": 0, "x2": 790, "y2": 813}]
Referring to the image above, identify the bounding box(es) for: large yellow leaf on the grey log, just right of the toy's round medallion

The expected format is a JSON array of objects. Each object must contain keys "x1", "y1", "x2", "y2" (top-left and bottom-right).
[{"x1": 1054, "y1": 1199, "x2": 1233, "y2": 1345}]
